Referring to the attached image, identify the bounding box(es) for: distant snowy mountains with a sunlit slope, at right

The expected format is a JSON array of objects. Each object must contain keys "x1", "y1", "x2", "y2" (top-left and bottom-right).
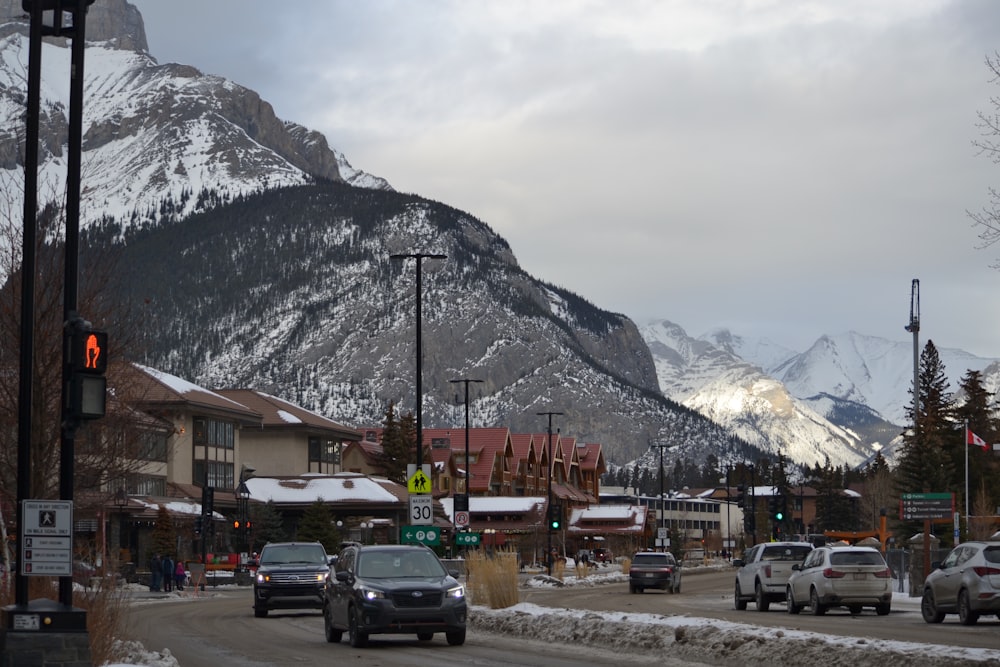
[{"x1": 641, "y1": 320, "x2": 1000, "y2": 465}]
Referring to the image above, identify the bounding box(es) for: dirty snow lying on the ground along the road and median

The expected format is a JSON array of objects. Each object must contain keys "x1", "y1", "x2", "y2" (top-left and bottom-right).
[{"x1": 101, "y1": 565, "x2": 1000, "y2": 667}]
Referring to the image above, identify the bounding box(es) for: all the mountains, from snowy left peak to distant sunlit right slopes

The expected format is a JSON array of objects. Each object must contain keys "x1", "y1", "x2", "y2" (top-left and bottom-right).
[{"x1": 0, "y1": 0, "x2": 1000, "y2": 474}]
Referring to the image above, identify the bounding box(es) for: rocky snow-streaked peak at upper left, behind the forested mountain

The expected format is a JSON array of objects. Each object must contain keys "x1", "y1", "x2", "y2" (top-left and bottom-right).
[{"x1": 0, "y1": 0, "x2": 389, "y2": 237}]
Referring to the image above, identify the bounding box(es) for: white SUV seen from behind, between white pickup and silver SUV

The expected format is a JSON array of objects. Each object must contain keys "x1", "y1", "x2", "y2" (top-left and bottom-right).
[{"x1": 786, "y1": 547, "x2": 892, "y2": 616}]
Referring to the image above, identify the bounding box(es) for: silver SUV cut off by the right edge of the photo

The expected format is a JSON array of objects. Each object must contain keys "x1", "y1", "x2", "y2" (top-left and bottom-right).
[{"x1": 920, "y1": 542, "x2": 1000, "y2": 625}]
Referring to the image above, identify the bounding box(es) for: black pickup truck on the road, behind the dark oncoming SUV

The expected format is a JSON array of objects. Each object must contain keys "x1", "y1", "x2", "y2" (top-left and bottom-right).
[{"x1": 250, "y1": 542, "x2": 331, "y2": 618}]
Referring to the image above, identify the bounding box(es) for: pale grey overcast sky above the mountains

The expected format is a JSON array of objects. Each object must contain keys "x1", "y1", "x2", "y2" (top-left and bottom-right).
[{"x1": 132, "y1": 0, "x2": 1000, "y2": 357}]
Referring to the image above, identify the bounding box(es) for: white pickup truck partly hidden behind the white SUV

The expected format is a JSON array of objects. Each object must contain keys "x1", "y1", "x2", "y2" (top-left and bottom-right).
[{"x1": 733, "y1": 542, "x2": 813, "y2": 611}]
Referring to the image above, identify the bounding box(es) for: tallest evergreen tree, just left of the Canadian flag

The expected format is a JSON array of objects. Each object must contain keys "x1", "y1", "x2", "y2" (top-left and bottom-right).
[{"x1": 896, "y1": 340, "x2": 957, "y2": 535}]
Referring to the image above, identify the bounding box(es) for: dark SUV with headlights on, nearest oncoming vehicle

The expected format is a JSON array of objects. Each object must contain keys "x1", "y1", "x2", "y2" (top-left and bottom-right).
[{"x1": 323, "y1": 544, "x2": 467, "y2": 648}]
